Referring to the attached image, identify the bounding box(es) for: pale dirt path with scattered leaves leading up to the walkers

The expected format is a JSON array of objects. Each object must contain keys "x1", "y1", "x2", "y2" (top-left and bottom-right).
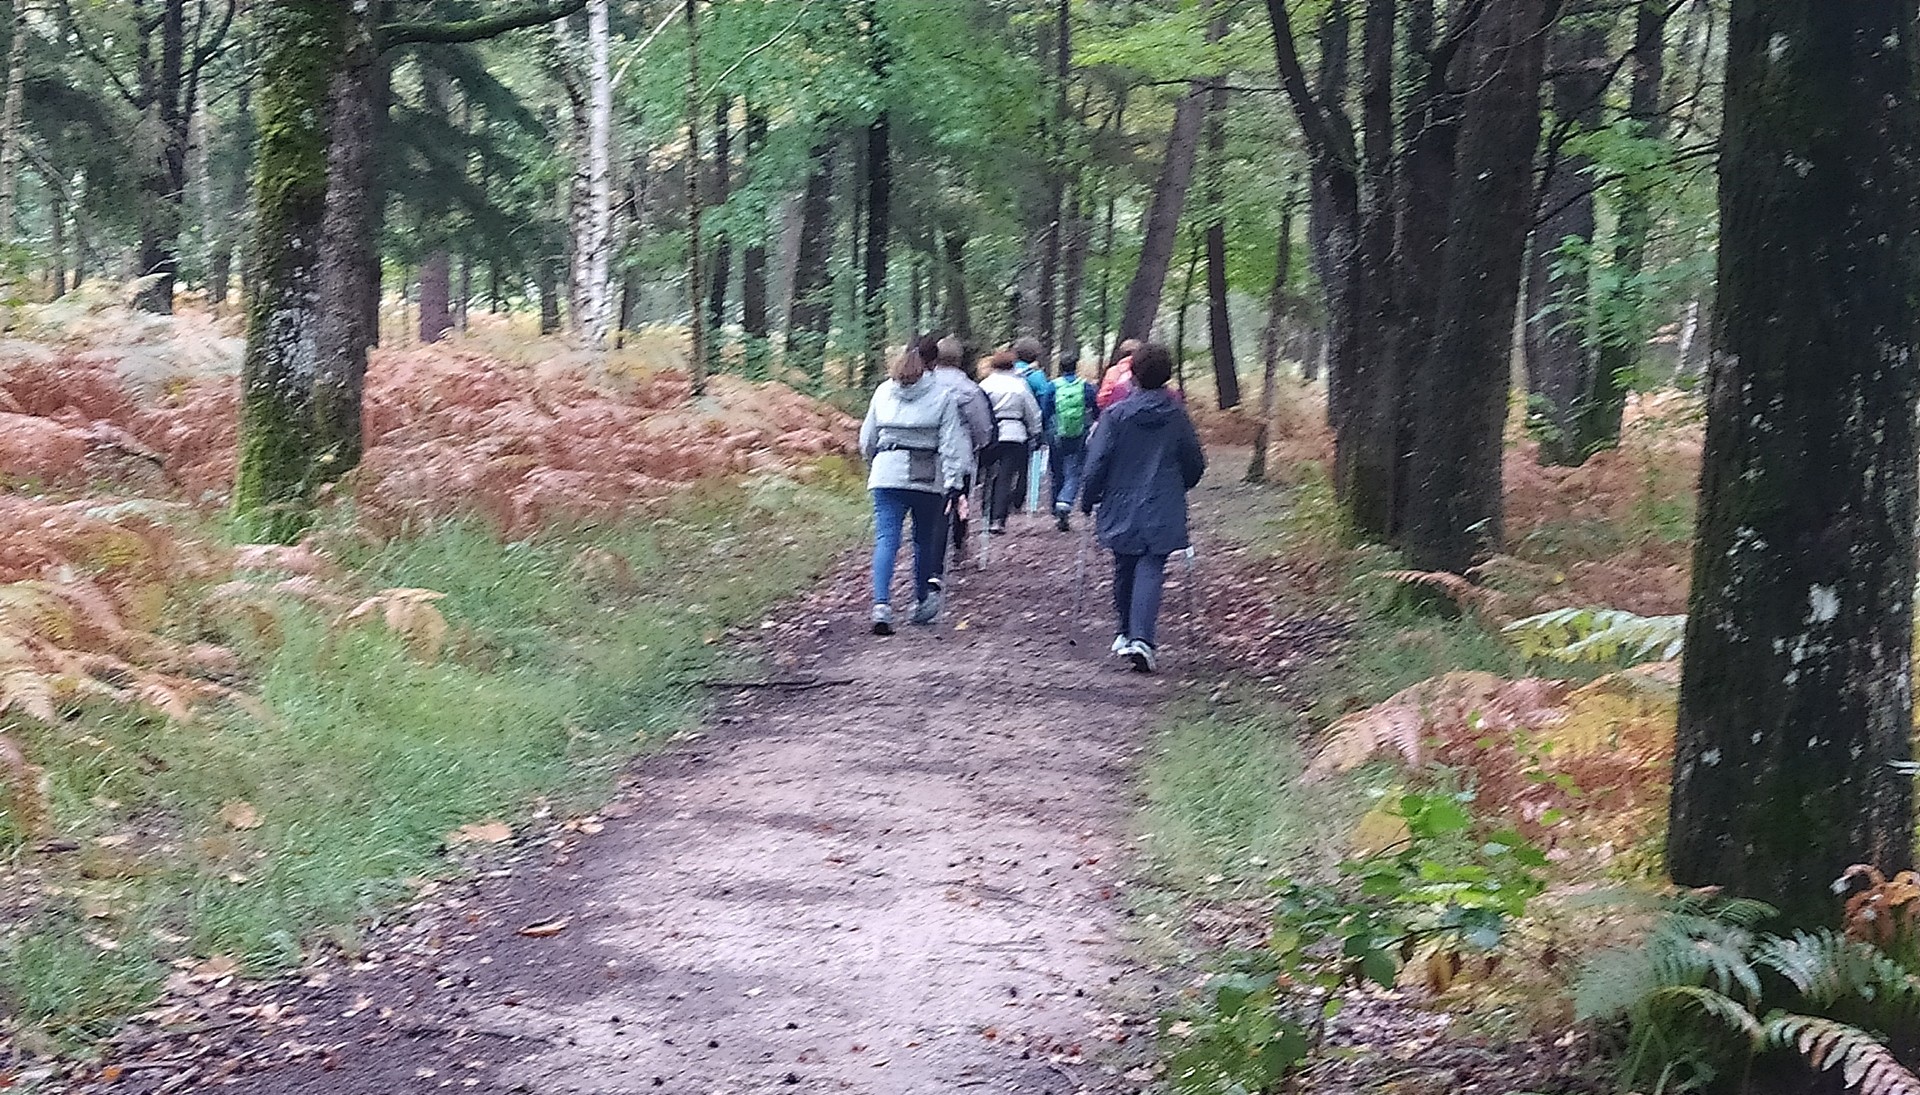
[{"x1": 112, "y1": 521, "x2": 1181, "y2": 1095}]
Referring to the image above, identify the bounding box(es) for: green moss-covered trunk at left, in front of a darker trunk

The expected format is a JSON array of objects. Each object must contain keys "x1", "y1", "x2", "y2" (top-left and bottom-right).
[{"x1": 234, "y1": 0, "x2": 348, "y2": 544}]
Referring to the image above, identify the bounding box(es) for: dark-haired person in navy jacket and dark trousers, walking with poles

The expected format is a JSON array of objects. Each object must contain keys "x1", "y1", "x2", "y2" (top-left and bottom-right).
[{"x1": 1081, "y1": 344, "x2": 1206, "y2": 672}]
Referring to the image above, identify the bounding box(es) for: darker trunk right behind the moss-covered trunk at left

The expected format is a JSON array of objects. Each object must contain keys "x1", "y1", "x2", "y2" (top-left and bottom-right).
[{"x1": 311, "y1": 15, "x2": 380, "y2": 482}]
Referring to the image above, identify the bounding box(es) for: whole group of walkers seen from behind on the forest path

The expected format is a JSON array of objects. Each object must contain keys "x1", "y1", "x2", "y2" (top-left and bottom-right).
[{"x1": 860, "y1": 334, "x2": 1206, "y2": 672}]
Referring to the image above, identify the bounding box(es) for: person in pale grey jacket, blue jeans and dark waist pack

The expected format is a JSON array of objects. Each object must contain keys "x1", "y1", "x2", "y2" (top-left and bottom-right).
[{"x1": 860, "y1": 341, "x2": 973, "y2": 636}]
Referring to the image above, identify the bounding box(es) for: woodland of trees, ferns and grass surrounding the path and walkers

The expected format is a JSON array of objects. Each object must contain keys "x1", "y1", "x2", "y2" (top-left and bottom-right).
[{"x1": 0, "y1": 0, "x2": 1920, "y2": 1095}]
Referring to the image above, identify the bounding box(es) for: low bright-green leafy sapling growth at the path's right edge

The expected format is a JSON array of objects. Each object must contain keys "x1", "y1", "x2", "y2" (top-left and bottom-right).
[{"x1": 1162, "y1": 791, "x2": 1546, "y2": 1095}]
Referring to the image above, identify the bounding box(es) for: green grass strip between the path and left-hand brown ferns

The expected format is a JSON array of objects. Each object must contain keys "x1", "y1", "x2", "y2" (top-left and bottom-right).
[{"x1": 0, "y1": 468, "x2": 864, "y2": 1049}]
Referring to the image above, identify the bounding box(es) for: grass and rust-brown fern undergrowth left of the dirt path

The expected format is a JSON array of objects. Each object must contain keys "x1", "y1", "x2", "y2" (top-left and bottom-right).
[{"x1": 0, "y1": 293, "x2": 864, "y2": 1053}]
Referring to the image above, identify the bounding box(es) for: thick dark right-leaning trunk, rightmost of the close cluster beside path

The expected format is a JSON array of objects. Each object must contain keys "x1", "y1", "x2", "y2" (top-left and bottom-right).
[{"x1": 1405, "y1": 0, "x2": 1548, "y2": 574}]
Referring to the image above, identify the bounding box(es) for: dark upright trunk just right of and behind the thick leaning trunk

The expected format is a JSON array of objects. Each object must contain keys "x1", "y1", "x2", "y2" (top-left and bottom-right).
[{"x1": 1524, "y1": 15, "x2": 1609, "y2": 467}]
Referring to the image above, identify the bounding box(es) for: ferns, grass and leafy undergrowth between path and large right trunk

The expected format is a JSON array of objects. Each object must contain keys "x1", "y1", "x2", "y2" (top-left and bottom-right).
[{"x1": 1140, "y1": 396, "x2": 1699, "y2": 1093}]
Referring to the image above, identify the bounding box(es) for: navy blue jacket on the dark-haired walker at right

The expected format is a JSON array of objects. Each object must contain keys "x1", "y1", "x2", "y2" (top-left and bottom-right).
[{"x1": 1081, "y1": 388, "x2": 1206, "y2": 555}]
